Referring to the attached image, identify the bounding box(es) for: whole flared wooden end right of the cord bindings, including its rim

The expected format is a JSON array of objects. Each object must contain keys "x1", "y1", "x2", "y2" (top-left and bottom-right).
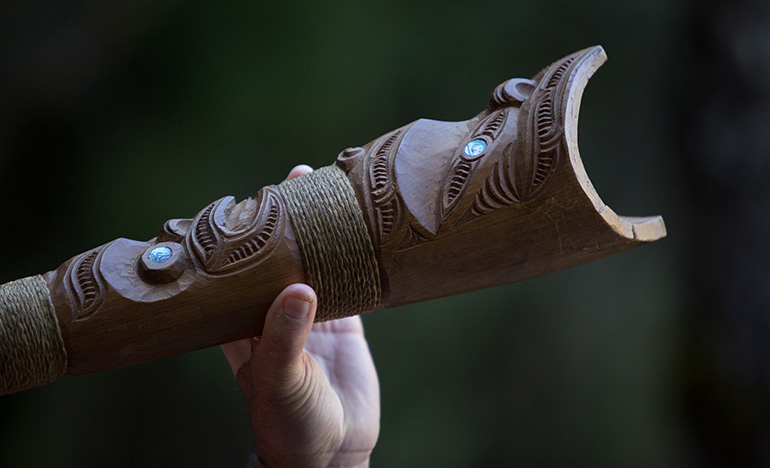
[{"x1": 341, "y1": 47, "x2": 665, "y2": 305}]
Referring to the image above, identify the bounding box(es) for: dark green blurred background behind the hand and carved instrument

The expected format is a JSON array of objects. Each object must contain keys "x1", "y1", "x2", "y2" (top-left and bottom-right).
[{"x1": 0, "y1": 0, "x2": 770, "y2": 468}]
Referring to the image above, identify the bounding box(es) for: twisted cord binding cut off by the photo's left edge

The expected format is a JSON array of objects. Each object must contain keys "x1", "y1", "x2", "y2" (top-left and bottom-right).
[{"x1": 0, "y1": 275, "x2": 67, "y2": 395}]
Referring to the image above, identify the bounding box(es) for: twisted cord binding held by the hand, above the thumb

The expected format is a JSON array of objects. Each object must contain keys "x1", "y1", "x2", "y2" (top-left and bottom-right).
[{"x1": 278, "y1": 166, "x2": 382, "y2": 322}]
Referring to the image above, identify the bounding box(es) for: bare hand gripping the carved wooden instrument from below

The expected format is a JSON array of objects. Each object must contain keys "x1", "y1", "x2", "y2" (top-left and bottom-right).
[{"x1": 222, "y1": 166, "x2": 380, "y2": 468}]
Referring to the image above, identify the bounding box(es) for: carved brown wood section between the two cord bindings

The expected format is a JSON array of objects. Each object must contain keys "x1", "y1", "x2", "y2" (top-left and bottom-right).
[{"x1": 46, "y1": 186, "x2": 305, "y2": 374}]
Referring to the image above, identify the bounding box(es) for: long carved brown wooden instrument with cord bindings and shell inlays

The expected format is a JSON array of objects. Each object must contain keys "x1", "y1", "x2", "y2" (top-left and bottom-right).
[{"x1": 0, "y1": 47, "x2": 665, "y2": 394}]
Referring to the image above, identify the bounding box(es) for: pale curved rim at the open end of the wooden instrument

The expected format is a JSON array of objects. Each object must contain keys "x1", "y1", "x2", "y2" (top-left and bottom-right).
[{"x1": 564, "y1": 46, "x2": 666, "y2": 242}]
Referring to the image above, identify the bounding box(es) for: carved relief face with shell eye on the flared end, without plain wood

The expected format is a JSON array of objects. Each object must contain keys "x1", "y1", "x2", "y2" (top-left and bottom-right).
[{"x1": 338, "y1": 49, "x2": 581, "y2": 251}]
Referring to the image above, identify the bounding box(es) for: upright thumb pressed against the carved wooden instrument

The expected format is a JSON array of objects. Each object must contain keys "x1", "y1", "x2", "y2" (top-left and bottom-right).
[{"x1": 251, "y1": 284, "x2": 317, "y2": 386}]
